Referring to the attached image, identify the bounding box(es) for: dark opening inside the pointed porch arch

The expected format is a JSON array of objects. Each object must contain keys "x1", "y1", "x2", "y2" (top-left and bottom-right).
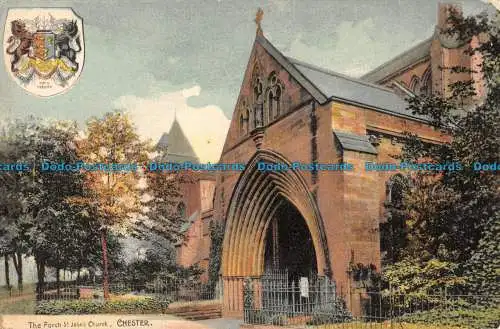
[{"x1": 265, "y1": 197, "x2": 317, "y2": 281}]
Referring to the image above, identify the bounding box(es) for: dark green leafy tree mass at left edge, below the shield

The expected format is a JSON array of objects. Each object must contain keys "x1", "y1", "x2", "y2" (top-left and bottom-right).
[{"x1": 0, "y1": 118, "x2": 97, "y2": 293}]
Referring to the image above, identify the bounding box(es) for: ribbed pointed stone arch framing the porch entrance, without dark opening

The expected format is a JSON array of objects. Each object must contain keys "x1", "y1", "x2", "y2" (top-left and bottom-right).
[{"x1": 221, "y1": 150, "x2": 332, "y2": 277}]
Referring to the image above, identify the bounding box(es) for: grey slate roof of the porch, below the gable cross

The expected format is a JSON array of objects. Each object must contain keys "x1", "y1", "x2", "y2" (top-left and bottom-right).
[{"x1": 256, "y1": 35, "x2": 426, "y2": 121}]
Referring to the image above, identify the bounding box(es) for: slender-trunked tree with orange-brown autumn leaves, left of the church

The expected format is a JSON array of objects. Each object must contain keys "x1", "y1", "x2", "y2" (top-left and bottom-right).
[{"x1": 72, "y1": 111, "x2": 149, "y2": 298}]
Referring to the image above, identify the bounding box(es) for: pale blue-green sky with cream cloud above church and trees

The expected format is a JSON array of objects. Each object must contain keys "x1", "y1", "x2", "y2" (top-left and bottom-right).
[{"x1": 0, "y1": 0, "x2": 487, "y2": 159}]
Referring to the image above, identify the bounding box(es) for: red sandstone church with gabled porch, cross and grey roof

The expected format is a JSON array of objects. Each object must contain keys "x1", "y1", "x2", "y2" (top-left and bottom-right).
[{"x1": 175, "y1": 4, "x2": 484, "y2": 315}]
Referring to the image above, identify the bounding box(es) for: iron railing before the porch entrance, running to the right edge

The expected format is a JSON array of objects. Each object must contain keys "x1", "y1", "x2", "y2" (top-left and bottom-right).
[{"x1": 244, "y1": 282, "x2": 500, "y2": 329}]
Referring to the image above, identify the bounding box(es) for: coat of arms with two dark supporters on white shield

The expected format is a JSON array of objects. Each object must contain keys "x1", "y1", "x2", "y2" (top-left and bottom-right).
[{"x1": 4, "y1": 8, "x2": 85, "y2": 96}]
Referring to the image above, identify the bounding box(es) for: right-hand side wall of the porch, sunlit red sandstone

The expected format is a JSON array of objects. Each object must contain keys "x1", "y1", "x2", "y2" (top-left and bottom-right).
[{"x1": 328, "y1": 99, "x2": 445, "y2": 300}]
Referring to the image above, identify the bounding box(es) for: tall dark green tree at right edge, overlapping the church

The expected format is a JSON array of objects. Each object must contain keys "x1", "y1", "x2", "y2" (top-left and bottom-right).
[{"x1": 386, "y1": 7, "x2": 500, "y2": 293}]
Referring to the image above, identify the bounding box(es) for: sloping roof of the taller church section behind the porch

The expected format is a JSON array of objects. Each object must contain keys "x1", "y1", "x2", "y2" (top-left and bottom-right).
[{"x1": 361, "y1": 35, "x2": 434, "y2": 83}]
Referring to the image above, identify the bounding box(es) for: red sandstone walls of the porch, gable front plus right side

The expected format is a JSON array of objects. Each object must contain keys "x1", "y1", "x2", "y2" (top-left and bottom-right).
[{"x1": 215, "y1": 33, "x2": 450, "y2": 302}]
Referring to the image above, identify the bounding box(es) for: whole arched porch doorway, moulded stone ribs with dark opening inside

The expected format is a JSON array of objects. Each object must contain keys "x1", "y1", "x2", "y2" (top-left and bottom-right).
[{"x1": 221, "y1": 150, "x2": 332, "y2": 315}]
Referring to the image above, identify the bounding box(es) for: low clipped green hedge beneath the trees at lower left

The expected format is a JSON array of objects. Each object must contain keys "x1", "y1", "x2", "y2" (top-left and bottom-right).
[{"x1": 35, "y1": 297, "x2": 169, "y2": 315}]
